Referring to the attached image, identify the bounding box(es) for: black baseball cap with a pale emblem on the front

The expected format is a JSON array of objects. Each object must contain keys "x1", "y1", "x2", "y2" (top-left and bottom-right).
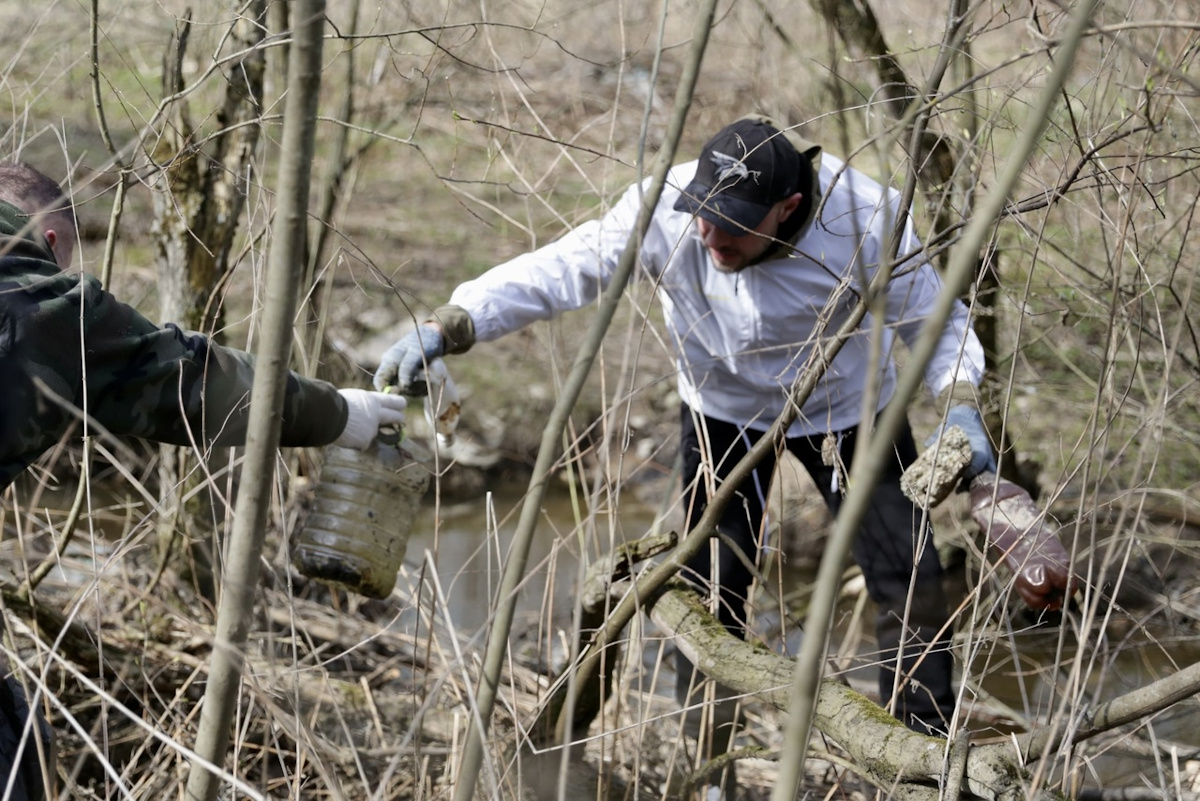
[{"x1": 674, "y1": 119, "x2": 800, "y2": 234}]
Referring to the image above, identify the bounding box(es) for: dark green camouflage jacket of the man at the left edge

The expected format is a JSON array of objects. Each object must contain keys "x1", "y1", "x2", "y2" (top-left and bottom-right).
[{"x1": 0, "y1": 203, "x2": 347, "y2": 489}]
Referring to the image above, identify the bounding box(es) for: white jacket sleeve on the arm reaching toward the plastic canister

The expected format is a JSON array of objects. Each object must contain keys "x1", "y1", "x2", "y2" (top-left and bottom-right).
[{"x1": 450, "y1": 176, "x2": 641, "y2": 342}]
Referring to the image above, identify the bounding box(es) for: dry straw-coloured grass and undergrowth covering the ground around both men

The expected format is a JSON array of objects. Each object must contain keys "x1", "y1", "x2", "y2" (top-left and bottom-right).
[{"x1": 0, "y1": 0, "x2": 1200, "y2": 799}]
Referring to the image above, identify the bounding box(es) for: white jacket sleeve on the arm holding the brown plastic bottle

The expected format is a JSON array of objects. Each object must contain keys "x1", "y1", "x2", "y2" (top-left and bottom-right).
[{"x1": 888, "y1": 221, "x2": 984, "y2": 396}]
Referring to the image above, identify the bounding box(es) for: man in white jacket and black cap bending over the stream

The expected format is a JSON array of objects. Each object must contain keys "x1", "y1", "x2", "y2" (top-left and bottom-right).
[{"x1": 376, "y1": 118, "x2": 992, "y2": 731}]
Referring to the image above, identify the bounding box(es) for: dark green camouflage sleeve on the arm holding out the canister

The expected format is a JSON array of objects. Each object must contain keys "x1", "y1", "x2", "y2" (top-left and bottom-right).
[{"x1": 28, "y1": 276, "x2": 347, "y2": 446}]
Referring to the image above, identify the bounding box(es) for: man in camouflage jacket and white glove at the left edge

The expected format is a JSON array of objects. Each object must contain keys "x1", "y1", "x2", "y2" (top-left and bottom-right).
[{"x1": 0, "y1": 164, "x2": 406, "y2": 801}]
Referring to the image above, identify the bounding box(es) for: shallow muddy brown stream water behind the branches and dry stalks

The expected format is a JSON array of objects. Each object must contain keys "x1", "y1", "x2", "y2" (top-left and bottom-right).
[{"x1": 396, "y1": 486, "x2": 1200, "y2": 795}]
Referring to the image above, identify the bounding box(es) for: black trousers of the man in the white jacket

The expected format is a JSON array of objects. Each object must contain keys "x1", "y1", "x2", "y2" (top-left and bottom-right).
[{"x1": 679, "y1": 405, "x2": 954, "y2": 733}]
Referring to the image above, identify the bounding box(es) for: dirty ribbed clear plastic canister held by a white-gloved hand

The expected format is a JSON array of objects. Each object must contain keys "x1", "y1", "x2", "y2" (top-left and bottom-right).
[{"x1": 292, "y1": 428, "x2": 430, "y2": 598}]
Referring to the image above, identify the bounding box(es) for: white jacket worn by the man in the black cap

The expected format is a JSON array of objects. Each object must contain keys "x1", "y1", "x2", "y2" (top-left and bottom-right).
[{"x1": 450, "y1": 149, "x2": 984, "y2": 436}]
